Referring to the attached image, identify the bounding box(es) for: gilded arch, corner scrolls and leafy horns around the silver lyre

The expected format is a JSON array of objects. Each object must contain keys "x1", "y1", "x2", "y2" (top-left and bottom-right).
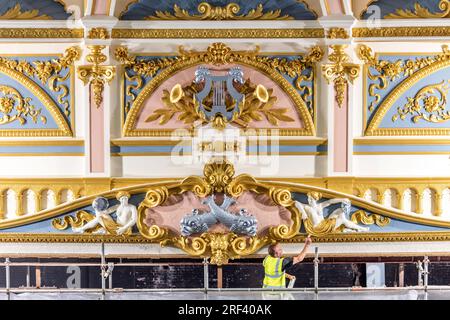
[{"x1": 115, "y1": 43, "x2": 323, "y2": 135}]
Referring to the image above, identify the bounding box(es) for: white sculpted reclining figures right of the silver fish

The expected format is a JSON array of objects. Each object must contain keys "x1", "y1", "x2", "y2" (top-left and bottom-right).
[{"x1": 295, "y1": 192, "x2": 369, "y2": 232}]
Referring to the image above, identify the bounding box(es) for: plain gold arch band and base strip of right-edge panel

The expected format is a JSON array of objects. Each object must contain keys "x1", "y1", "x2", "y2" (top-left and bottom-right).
[{"x1": 364, "y1": 59, "x2": 450, "y2": 136}]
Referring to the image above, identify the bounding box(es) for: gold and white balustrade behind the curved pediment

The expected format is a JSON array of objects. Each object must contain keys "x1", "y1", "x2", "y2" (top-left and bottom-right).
[{"x1": 0, "y1": 177, "x2": 450, "y2": 220}]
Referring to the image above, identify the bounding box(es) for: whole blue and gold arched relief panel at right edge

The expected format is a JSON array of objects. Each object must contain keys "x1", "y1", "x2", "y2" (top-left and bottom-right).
[{"x1": 357, "y1": 45, "x2": 450, "y2": 136}]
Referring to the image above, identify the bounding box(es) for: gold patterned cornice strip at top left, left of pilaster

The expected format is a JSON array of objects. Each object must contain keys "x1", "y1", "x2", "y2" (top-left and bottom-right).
[{"x1": 0, "y1": 28, "x2": 84, "y2": 39}]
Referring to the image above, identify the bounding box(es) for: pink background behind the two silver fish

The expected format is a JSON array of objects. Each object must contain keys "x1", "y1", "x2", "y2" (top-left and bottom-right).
[{"x1": 145, "y1": 192, "x2": 292, "y2": 234}]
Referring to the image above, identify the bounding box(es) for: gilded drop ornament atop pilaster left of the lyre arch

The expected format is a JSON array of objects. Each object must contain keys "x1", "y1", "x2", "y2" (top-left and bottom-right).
[{"x1": 77, "y1": 45, "x2": 116, "y2": 108}]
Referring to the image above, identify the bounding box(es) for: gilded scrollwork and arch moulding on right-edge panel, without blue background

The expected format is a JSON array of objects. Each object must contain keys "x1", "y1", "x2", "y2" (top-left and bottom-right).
[{"x1": 357, "y1": 45, "x2": 450, "y2": 135}]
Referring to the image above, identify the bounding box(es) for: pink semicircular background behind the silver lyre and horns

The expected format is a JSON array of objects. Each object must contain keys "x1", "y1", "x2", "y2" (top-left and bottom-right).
[{"x1": 136, "y1": 65, "x2": 303, "y2": 129}]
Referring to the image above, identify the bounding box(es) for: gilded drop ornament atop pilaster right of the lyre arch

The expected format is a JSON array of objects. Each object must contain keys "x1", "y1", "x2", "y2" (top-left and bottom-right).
[{"x1": 322, "y1": 45, "x2": 360, "y2": 107}]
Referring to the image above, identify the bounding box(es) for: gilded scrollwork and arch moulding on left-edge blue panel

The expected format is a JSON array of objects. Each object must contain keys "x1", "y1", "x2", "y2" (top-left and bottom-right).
[{"x1": 0, "y1": 47, "x2": 80, "y2": 136}]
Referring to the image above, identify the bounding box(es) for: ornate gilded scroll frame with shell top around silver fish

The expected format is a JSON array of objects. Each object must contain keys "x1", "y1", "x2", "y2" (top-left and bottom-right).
[{"x1": 137, "y1": 159, "x2": 301, "y2": 265}]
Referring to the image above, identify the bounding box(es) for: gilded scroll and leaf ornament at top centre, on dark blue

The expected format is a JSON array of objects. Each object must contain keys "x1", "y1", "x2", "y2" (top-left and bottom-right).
[{"x1": 145, "y1": 2, "x2": 293, "y2": 20}]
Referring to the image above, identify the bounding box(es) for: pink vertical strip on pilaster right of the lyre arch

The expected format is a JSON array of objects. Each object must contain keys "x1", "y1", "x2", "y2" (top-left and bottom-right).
[{"x1": 334, "y1": 86, "x2": 348, "y2": 172}]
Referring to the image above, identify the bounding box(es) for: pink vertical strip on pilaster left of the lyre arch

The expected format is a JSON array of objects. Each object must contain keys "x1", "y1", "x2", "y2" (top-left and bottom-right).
[{"x1": 89, "y1": 86, "x2": 105, "y2": 173}]
